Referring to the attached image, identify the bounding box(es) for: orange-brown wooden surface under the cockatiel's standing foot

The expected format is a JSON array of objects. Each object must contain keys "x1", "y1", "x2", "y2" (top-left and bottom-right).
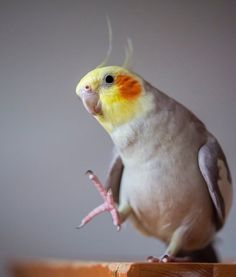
[{"x1": 9, "y1": 261, "x2": 236, "y2": 277}]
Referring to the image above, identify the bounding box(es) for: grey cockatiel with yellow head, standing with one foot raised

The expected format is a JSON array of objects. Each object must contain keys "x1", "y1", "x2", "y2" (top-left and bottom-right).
[{"x1": 76, "y1": 62, "x2": 232, "y2": 262}]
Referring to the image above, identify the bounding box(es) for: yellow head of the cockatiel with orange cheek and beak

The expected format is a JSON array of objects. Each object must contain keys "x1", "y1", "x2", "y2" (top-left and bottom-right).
[{"x1": 76, "y1": 66, "x2": 150, "y2": 132}]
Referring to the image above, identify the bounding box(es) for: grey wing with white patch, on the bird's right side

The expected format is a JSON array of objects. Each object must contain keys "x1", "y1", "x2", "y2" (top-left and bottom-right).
[{"x1": 198, "y1": 134, "x2": 232, "y2": 230}]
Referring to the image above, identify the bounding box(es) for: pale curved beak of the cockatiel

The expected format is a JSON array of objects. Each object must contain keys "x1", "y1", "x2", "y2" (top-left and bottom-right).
[{"x1": 79, "y1": 90, "x2": 102, "y2": 116}]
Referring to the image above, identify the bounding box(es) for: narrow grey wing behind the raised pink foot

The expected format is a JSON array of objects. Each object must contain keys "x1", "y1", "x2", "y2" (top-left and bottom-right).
[{"x1": 106, "y1": 147, "x2": 124, "y2": 203}]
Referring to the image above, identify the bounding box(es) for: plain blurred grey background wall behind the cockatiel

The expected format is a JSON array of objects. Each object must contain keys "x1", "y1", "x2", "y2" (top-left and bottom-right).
[{"x1": 0, "y1": 0, "x2": 236, "y2": 275}]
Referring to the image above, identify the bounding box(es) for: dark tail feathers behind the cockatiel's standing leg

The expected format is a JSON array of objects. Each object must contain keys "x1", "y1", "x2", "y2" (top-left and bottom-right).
[{"x1": 177, "y1": 243, "x2": 219, "y2": 263}]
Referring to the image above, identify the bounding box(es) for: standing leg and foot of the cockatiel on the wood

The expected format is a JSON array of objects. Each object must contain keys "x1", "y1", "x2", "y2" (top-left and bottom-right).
[{"x1": 147, "y1": 226, "x2": 190, "y2": 263}]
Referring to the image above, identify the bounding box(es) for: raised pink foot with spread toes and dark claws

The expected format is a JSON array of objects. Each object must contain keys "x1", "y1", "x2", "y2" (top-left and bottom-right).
[{"x1": 77, "y1": 170, "x2": 121, "y2": 231}]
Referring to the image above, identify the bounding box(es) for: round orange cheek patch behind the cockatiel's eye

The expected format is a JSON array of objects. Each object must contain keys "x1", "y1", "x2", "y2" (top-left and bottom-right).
[{"x1": 116, "y1": 75, "x2": 142, "y2": 100}]
